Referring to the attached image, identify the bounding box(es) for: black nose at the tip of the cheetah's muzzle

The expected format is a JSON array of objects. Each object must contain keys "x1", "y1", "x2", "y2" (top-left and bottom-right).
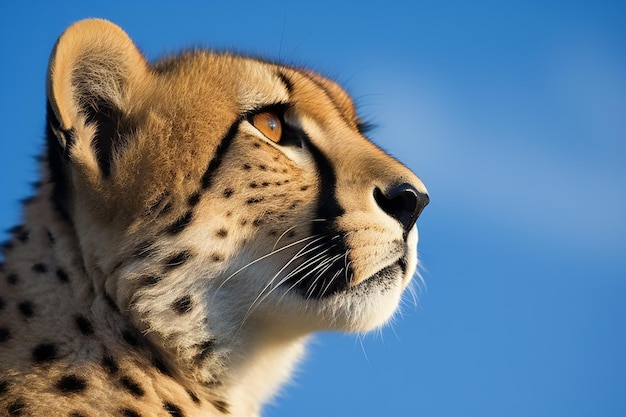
[{"x1": 374, "y1": 183, "x2": 430, "y2": 232}]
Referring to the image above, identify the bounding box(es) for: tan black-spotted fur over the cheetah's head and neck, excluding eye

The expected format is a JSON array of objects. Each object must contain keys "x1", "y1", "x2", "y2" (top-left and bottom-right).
[{"x1": 0, "y1": 20, "x2": 426, "y2": 416}]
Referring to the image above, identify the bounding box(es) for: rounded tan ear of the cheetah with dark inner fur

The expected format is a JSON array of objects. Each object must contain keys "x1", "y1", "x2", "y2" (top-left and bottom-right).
[{"x1": 47, "y1": 19, "x2": 149, "y2": 177}]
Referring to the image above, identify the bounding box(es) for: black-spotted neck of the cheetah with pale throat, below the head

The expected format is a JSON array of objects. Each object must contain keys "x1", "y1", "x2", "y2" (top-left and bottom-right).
[{"x1": 0, "y1": 180, "x2": 305, "y2": 416}]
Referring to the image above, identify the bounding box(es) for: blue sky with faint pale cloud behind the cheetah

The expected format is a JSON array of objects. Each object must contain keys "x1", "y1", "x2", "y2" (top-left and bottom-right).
[{"x1": 0, "y1": 1, "x2": 626, "y2": 417}]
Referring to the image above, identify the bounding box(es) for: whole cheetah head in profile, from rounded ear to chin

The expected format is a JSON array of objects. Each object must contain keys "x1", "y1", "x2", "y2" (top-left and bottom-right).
[{"x1": 48, "y1": 21, "x2": 428, "y2": 349}]
